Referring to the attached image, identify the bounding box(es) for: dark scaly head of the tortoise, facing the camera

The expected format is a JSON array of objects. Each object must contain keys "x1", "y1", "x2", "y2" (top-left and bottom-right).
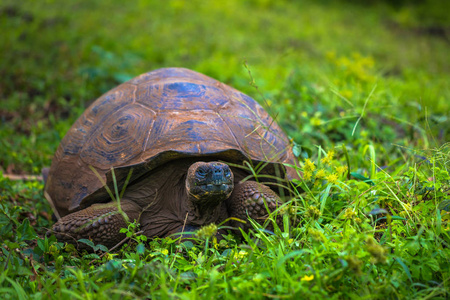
[{"x1": 186, "y1": 161, "x2": 234, "y2": 207}]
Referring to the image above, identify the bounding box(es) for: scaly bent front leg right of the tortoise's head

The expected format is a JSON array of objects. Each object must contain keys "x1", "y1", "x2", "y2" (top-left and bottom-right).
[{"x1": 227, "y1": 181, "x2": 282, "y2": 231}]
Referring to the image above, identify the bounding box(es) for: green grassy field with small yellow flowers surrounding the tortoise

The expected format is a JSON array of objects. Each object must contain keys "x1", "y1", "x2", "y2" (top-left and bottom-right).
[{"x1": 0, "y1": 0, "x2": 450, "y2": 299}]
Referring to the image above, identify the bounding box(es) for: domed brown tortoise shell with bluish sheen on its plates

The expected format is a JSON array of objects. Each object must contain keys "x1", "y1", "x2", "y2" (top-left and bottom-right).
[{"x1": 45, "y1": 68, "x2": 296, "y2": 217}]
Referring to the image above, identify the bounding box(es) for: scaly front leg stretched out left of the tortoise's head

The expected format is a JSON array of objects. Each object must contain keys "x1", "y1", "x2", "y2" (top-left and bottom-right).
[{"x1": 52, "y1": 200, "x2": 141, "y2": 249}]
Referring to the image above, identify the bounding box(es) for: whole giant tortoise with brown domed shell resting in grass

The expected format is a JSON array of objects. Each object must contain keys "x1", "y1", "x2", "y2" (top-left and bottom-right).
[{"x1": 44, "y1": 68, "x2": 298, "y2": 247}]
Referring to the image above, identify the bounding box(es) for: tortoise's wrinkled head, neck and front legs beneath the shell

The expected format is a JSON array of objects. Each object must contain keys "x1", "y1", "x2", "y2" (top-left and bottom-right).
[{"x1": 52, "y1": 161, "x2": 281, "y2": 247}]
